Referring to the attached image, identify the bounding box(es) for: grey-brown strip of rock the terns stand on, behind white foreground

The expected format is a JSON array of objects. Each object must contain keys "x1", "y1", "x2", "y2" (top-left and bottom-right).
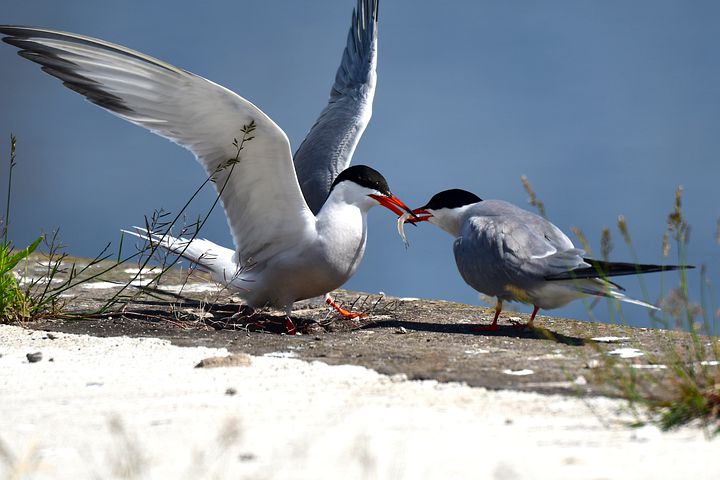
[{"x1": 15, "y1": 255, "x2": 717, "y2": 395}]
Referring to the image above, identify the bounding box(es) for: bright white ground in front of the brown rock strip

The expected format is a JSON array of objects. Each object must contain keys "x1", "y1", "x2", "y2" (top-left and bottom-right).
[{"x1": 0, "y1": 326, "x2": 720, "y2": 480}]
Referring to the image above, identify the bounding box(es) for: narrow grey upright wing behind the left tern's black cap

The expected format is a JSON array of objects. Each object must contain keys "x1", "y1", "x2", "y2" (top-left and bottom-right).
[{"x1": 295, "y1": 0, "x2": 379, "y2": 214}]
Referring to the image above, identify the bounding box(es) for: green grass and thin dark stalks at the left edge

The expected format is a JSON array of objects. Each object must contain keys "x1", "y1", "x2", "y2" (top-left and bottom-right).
[{"x1": 0, "y1": 125, "x2": 256, "y2": 323}]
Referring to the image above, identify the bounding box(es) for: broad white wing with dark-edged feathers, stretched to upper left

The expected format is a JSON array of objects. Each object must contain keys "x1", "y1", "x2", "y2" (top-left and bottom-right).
[{"x1": 0, "y1": 26, "x2": 314, "y2": 261}]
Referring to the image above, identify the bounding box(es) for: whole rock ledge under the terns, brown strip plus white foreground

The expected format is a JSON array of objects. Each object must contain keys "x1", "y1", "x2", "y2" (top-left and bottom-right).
[{"x1": 0, "y1": 255, "x2": 720, "y2": 480}]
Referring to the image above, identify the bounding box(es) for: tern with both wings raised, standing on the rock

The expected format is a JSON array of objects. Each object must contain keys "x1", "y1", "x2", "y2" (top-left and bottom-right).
[{"x1": 0, "y1": 0, "x2": 410, "y2": 326}]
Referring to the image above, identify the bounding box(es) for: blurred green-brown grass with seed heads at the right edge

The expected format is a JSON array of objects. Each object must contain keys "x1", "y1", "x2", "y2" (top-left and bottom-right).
[{"x1": 521, "y1": 177, "x2": 720, "y2": 436}]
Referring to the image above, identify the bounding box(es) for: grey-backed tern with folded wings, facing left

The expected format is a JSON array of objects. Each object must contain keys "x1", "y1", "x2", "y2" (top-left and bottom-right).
[{"x1": 398, "y1": 189, "x2": 693, "y2": 330}]
